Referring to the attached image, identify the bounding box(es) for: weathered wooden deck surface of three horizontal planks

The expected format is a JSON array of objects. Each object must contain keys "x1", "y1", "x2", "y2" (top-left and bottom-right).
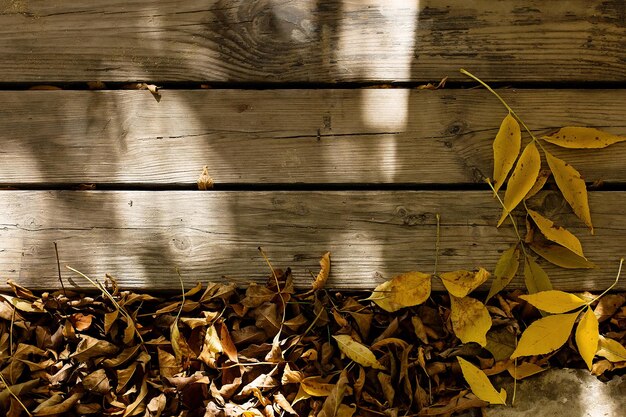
[{"x1": 0, "y1": 0, "x2": 626, "y2": 290}]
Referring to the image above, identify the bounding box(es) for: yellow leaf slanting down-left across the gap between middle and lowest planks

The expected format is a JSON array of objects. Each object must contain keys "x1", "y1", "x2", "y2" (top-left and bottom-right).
[{"x1": 498, "y1": 142, "x2": 541, "y2": 226}]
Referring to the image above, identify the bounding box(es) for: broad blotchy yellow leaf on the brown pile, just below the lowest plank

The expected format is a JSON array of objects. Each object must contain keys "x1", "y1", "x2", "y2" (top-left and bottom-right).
[{"x1": 450, "y1": 295, "x2": 491, "y2": 347}]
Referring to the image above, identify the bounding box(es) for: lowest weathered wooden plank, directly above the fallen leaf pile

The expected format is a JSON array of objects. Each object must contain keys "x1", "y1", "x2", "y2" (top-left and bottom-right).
[{"x1": 0, "y1": 191, "x2": 626, "y2": 290}]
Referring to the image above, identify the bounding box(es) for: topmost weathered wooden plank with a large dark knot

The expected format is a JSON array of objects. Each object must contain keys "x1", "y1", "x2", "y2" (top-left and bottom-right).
[{"x1": 0, "y1": 0, "x2": 626, "y2": 82}]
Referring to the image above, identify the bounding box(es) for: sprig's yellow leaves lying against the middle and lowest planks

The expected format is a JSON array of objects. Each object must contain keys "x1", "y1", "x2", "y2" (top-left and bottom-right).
[{"x1": 488, "y1": 101, "x2": 626, "y2": 298}]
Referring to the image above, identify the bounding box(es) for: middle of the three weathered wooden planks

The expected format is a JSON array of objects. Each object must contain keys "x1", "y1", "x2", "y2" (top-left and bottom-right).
[{"x1": 0, "y1": 89, "x2": 626, "y2": 185}]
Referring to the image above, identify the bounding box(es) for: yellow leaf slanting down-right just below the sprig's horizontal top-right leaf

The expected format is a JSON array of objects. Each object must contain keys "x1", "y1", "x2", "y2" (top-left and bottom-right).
[{"x1": 546, "y1": 152, "x2": 593, "y2": 234}]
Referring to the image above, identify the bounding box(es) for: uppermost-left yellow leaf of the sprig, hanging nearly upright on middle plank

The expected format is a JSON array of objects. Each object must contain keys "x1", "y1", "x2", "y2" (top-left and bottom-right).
[{"x1": 493, "y1": 113, "x2": 522, "y2": 192}]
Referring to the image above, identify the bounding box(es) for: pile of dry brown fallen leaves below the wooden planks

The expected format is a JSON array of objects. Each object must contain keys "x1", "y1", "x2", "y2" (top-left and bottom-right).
[{"x1": 0, "y1": 256, "x2": 626, "y2": 417}]
